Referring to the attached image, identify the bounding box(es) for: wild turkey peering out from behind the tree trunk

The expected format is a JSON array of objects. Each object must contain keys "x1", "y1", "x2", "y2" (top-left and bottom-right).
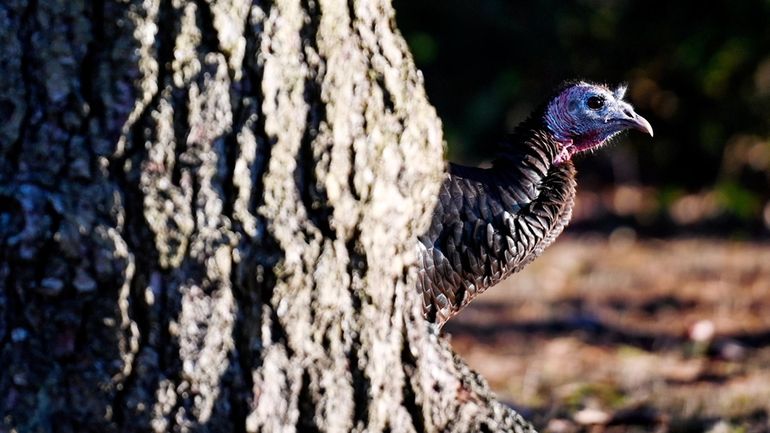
[{"x1": 417, "y1": 82, "x2": 652, "y2": 326}]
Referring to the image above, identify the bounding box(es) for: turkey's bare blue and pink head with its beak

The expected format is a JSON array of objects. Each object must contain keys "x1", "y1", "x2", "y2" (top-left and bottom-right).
[{"x1": 545, "y1": 82, "x2": 652, "y2": 164}]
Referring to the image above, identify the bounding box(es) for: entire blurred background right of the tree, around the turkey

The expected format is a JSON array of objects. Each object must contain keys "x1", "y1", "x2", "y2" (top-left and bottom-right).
[{"x1": 394, "y1": 0, "x2": 770, "y2": 432}]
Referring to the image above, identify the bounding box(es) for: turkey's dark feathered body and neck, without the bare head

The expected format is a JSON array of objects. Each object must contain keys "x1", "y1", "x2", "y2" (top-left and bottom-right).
[{"x1": 417, "y1": 118, "x2": 575, "y2": 326}]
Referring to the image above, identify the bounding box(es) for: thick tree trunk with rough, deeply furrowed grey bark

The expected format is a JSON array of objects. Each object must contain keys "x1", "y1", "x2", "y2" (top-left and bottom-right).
[{"x1": 0, "y1": 0, "x2": 532, "y2": 432}]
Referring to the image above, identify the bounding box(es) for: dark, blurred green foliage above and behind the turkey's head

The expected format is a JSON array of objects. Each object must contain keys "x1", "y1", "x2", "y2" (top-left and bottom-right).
[{"x1": 395, "y1": 0, "x2": 770, "y2": 230}]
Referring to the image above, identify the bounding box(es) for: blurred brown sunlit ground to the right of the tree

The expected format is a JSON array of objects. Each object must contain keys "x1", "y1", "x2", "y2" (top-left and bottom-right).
[{"x1": 445, "y1": 235, "x2": 770, "y2": 433}]
